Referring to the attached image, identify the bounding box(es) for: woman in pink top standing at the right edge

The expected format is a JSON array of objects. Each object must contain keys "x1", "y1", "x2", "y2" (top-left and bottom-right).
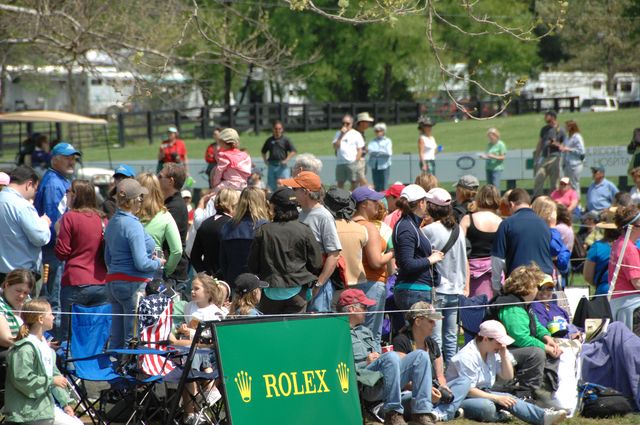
[{"x1": 609, "y1": 205, "x2": 640, "y2": 335}]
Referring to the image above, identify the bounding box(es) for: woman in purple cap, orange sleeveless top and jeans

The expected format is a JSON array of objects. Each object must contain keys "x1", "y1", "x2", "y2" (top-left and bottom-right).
[{"x1": 350, "y1": 186, "x2": 393, "y2": 344}]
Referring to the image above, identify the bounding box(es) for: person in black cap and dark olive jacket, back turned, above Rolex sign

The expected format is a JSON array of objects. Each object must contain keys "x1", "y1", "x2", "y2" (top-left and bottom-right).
[{"x1": 248, "y1": 187, "x2": 322, "y2": 314}]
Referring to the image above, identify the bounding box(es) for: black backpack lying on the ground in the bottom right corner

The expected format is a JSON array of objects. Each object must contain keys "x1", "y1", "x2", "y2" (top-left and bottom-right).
[{"x1": 578, "y1": 383, "x2": 635, "y2": 418}]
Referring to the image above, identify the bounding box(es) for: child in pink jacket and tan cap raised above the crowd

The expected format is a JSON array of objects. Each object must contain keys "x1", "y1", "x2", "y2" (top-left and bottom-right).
[{"x1": 211, "y1": 128, "x2": 251, "y2": 193}]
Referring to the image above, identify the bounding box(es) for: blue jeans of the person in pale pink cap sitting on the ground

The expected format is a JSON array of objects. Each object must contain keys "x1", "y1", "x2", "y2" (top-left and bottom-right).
[{"x1": 460, "y1": 391, "x2": 544, "y2": 425}]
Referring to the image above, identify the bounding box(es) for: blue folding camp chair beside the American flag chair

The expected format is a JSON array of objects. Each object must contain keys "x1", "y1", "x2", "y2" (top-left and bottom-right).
[{"x1": 61, "y1": 304, "x2": 168, "y2": 425}]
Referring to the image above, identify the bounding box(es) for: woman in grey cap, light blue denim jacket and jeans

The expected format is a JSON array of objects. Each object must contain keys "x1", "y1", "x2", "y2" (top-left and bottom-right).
[{"x1": 104, "y1": 179, "x2": 166, "y2": 348}]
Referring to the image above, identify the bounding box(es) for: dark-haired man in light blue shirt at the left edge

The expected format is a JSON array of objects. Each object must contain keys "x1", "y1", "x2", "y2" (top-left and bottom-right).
[{"x1": 0, "y1": 166, "x2": 51, "y2": 282}]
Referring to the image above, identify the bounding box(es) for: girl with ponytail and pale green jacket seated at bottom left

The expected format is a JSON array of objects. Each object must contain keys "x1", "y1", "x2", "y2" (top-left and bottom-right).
[{"x1": 4, "y1": 299, "x2": 82, "y2": 425}]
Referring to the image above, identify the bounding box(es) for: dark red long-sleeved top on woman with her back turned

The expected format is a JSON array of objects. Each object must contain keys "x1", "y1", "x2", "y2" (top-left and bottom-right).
[{"x1": 55, "y1": 211, "x2": 107, "y2": 286}]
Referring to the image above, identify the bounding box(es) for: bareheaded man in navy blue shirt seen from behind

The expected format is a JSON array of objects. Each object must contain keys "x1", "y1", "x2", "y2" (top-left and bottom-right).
[{"x1": 491, "y1": 188, "x2": 553, "y2": 293}]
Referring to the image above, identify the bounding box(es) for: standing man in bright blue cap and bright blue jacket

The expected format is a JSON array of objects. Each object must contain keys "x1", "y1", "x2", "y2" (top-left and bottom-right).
[{"x1": 34, "y1": 142, "x2": 80, "y2": 310}]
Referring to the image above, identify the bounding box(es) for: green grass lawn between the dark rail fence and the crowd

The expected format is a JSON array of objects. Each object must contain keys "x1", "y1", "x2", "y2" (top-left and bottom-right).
[{"x1": 70, "y1": 108, "x2": 640, "y2": 161}]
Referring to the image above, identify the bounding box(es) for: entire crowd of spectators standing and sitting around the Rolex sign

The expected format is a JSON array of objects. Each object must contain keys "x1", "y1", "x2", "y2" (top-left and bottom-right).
[{"x1": 0, "y1": 112, "x2": 640, "y2": 425}]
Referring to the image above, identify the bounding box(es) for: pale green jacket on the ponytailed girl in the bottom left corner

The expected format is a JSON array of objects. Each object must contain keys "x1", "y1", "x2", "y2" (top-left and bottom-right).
[{"x1": 4, "y1": 339, "x2": 71, "y2": 422}]
